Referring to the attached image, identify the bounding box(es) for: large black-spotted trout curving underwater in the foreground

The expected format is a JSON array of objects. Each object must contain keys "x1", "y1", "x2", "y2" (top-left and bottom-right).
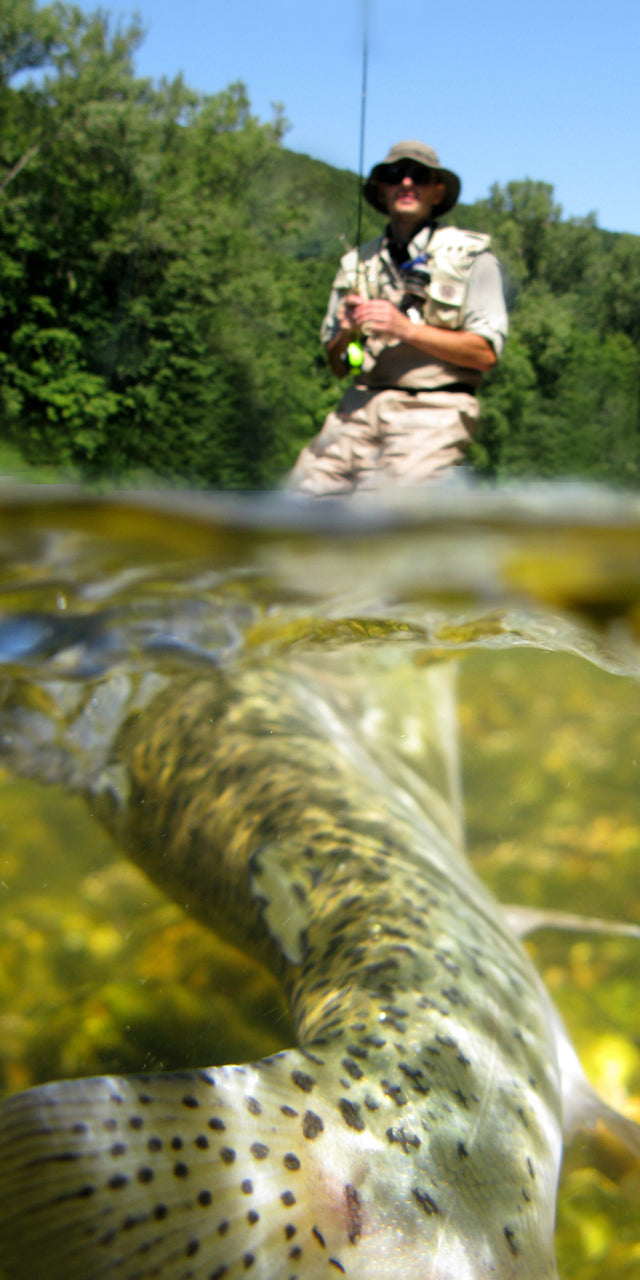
[{"x1": 0, "y1": 659, "x2": 640, "y2": 1280}]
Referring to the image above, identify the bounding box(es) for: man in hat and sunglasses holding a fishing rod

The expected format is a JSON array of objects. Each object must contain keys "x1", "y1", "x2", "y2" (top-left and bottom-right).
[{"x1": 288, "y1": 141, "x2": 508, "y2": 497}]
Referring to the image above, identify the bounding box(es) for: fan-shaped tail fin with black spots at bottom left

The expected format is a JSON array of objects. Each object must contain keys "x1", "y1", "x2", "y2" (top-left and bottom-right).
[{"x1": 0, "y1": 1051, "x2": 371, "y2": 1280}]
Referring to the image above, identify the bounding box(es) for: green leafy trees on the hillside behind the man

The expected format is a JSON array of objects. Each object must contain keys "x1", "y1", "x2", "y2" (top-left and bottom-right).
[{"x1": 0, "y1": 0, "x2": 640, "y2": 488}]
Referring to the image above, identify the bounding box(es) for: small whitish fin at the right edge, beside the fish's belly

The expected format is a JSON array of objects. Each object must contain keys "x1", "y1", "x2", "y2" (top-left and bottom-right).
[{"x1": 550, "y1": 1004, "x2": 640, "y2": 1160}]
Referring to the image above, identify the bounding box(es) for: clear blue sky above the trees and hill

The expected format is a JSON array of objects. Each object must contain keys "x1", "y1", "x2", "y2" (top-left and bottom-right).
[{"x1": 83, "y1": 0, "x2": 640, "y2": 234}]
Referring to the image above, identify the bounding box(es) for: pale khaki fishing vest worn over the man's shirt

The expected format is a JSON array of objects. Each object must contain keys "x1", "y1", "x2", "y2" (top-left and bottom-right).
[{"x1": 350, "y1": 227, "x2": 490, "y2": 329}]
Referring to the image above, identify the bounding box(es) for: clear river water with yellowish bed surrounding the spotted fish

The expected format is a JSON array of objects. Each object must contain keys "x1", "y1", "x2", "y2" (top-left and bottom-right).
[{"x1": 0, "y1": 485, "x2": 640, "y2": 1280}]
